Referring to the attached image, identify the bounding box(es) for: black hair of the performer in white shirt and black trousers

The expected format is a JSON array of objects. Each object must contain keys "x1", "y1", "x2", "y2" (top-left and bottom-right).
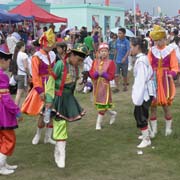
[{"x1": 131, "y1": 37, "x2": 148, "y2": 54}]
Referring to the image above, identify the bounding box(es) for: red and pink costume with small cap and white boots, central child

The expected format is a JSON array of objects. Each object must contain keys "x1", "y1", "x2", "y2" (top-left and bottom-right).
[{"x1": 89, "y1": 43, "x2": 117, "y2": 130}]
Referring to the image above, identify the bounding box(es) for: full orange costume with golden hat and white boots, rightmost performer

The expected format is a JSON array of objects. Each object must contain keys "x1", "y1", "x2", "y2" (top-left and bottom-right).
[{"x1": 148, "y1": 25, "x2": 178, "y2": 136}]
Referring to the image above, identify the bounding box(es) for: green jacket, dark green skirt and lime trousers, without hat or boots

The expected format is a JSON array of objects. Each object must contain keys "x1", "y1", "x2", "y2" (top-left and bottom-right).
[{"x1": 46, "y1": 58, "x2": 85, "y2": 140}]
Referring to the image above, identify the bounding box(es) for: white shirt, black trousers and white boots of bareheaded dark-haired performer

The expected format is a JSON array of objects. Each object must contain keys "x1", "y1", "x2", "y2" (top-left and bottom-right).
[{"x1": 132, "y1": 53, "x2": 156, "y2": 148}]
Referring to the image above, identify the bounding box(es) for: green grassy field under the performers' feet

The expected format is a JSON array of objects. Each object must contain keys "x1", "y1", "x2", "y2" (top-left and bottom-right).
[{"x1": 0, "y1": 76, "x2": 180, "y2": 180}]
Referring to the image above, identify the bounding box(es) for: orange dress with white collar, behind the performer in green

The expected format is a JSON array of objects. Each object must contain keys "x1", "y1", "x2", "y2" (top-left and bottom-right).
[{"x1": 21, "y1": 49, "x2": 56, "y2": 115}]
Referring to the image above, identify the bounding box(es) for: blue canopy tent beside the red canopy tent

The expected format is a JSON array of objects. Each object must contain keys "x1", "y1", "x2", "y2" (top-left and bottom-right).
[{"x1": 0, "y1": 9, "x2": 34, "y2": 24}]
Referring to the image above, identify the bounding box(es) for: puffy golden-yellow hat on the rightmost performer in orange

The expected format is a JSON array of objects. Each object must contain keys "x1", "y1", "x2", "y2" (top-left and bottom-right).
[{"x1": 150, "y1": 25, "x2": 166, "y2": 41}]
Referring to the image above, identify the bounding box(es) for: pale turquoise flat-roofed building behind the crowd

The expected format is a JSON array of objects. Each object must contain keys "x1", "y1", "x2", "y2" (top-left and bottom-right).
[{"x1": 51, "y1": 3, "x2": 125, "y2": 35}]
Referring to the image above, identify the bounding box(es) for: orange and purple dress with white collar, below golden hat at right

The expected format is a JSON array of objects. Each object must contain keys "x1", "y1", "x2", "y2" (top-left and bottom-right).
[{"x1": 148, "y1": 46, "x2": 178, "y2": 105}]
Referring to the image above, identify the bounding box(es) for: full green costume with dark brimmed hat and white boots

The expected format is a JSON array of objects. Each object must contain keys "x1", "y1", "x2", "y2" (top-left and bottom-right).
[{"x1": 46, "y1": 44, "x2": 87, "y2": 168}]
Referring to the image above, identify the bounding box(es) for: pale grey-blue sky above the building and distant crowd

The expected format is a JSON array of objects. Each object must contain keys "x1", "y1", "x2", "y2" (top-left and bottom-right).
[{"x1": 0, "y1": 0, "x2": 180, "y2": 16}]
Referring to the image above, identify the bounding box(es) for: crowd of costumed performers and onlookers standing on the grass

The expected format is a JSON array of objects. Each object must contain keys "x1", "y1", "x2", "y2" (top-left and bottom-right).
[{"x1": 0, "y1": 17, "x2": 180, "y2": 175}]
